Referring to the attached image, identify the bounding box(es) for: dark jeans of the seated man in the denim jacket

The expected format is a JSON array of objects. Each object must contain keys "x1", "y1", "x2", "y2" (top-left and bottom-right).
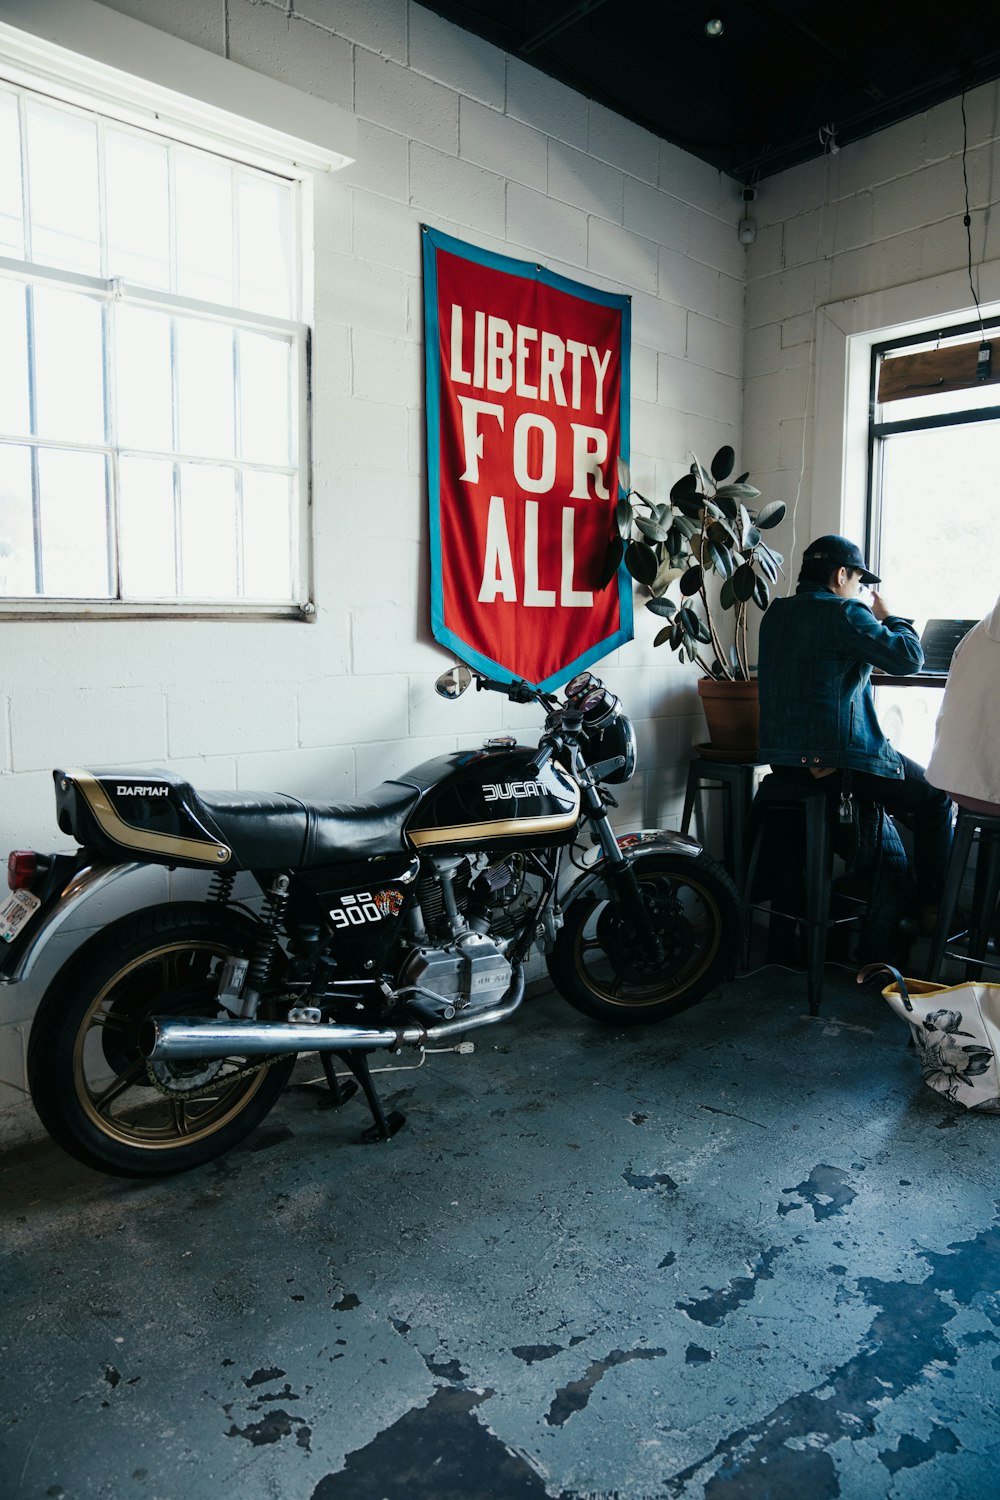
[{"x1": 772, "y1": 756, "x2": 952, "y2": 906}]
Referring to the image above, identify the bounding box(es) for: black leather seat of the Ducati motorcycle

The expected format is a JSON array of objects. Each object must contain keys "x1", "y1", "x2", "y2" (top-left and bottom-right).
[{"x1": 196, "y1": 782, "x2": 420, "y2": 870}]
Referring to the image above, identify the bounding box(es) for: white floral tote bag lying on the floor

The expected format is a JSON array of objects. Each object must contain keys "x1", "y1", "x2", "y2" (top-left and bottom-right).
[{"x1": 858, "y1": 963, "x2": 1000, "y2": 1115}]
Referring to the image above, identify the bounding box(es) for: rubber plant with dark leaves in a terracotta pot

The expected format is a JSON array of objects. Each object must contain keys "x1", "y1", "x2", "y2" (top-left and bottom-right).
[{"x1": 606, "y1": 447, "x2": 786, "y2": 756}]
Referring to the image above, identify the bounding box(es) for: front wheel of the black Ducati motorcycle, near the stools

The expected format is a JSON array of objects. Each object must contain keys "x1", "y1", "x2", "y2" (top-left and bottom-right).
[{"x1": 547, "y1": 852, "x2": 739, "y2": 1026}]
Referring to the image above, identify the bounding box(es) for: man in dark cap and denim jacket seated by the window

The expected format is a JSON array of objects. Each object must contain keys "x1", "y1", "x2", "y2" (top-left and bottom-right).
[{"x1": 757, "y1": 536, "x2": 952, "y2": 930}]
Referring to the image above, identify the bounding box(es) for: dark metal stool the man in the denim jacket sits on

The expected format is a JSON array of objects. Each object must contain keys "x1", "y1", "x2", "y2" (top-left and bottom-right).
[{"x1": 742, "y1": 776, "x2": 867, "y2": 1016}]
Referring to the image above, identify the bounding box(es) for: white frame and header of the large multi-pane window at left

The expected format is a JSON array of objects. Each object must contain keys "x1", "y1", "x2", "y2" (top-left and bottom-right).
[{"x1": 0, "y1": 0, "x2": 355, "y2": 621}]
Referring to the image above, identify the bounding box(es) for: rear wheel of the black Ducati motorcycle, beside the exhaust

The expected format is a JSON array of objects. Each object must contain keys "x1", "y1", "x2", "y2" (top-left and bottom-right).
[{"x1": 28, "y1": 903, "x2": 295, "y2": 1178}]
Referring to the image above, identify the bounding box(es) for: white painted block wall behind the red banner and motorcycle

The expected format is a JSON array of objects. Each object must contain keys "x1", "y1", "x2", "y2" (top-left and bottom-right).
[{"x1": 0, "y1": 0, "x2": 744, "y2": 1142}]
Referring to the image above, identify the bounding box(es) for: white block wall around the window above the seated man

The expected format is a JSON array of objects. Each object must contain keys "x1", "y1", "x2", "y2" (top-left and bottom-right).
[{"x1": 742, "y1": 84, "x2": 1000, "y2": 590}]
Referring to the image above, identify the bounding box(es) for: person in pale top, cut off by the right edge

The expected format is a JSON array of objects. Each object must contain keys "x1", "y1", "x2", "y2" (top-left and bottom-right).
[{"x1": 927, "y1": 599, "x2": 1000, "y2": 818}]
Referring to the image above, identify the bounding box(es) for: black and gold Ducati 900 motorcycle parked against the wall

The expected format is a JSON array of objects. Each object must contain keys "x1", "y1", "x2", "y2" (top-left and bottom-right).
[{"x1": 0, "y1": 666, "x2": 739, "y2": 1178}]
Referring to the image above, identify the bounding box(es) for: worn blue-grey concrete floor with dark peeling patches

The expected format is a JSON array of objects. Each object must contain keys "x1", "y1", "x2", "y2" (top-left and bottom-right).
[{"x1": 0, "y1": 969, "x2": 1000, "y2": 1500}]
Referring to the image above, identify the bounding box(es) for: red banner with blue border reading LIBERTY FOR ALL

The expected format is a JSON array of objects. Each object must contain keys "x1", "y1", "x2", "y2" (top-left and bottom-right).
[{"x1": 424, "y1": 228, "x2": 633, "y2": 687}]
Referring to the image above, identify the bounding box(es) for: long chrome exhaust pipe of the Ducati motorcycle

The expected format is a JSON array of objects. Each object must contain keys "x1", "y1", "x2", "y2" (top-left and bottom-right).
[{"x1": 146, "y1": 968, "x2": 525, "y2": 1062}]
